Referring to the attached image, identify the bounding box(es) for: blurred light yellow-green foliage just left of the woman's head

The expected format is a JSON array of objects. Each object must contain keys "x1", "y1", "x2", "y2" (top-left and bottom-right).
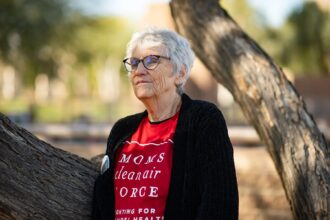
[{"x1": 62, "y1": 17, "x2": 131, "y2": 95}]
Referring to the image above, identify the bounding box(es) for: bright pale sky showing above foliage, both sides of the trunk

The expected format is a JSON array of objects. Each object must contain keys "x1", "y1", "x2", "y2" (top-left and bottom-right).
[{"x1": 79, "y1": 0, "x2": 304, "y2": 27}]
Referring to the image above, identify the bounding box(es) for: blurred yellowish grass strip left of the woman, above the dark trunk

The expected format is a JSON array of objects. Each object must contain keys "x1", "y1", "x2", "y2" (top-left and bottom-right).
[{"x1": 0, "y1": 99, "x2": 121, "y2": 123}]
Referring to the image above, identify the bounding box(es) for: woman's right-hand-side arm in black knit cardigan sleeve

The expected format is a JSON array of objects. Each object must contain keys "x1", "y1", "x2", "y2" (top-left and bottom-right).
[{"x1": 197, "y1": 107, "x2": 238, "y2": 220}]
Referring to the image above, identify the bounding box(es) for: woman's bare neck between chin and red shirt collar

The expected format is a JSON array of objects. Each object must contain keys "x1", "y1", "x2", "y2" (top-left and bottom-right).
[{"x1": 142, "y1": 93, "x2": 181, "y2": 122}]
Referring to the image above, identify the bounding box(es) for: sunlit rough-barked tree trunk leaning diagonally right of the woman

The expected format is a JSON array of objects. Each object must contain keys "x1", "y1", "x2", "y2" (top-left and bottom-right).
[{"x1": 170, "y1": 0, "x2": 330, "y2": 219}]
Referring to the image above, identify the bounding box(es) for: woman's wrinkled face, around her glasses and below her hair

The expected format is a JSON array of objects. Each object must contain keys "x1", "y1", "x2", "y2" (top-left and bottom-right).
[{"x1": 129, "y1": 45, "x2": 179, "y2": 100}]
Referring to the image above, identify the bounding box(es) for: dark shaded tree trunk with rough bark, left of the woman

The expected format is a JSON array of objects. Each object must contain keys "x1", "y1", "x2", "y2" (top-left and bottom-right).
[{"x1": 0, "y1": 113, "x2": 98, "y2": 219}]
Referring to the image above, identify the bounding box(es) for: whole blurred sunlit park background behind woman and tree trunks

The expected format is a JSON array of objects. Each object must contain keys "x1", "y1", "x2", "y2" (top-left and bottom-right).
[{"x1": 0, "y1": 0, "x2": 330, "y2": 219}]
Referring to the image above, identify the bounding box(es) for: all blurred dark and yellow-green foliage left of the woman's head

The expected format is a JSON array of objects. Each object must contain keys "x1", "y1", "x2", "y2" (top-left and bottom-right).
[{"x1": 0, "y1": 0, "x2": 134, "y2": 86}]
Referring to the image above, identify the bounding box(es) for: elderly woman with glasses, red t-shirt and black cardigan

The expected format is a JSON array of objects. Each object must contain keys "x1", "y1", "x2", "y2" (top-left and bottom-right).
[{"x1": 92, "y1": 28, "x2": 238, "y2": 220}]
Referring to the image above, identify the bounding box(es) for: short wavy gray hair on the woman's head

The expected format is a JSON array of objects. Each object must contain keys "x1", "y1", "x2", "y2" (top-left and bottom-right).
[{"x1": 126, "y1": 27, "x2": 195, "y2": 94}]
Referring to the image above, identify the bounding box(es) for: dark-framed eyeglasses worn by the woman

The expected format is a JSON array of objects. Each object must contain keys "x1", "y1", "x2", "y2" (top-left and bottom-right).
[{"x1": 123, "y1": 55, "x2": 171, "y2": 72}]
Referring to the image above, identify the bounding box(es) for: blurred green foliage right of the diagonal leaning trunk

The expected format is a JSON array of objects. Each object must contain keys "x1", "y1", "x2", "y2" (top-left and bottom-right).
[{"x1": 221, "y1": 0, "x2": 330, "y2": 75}]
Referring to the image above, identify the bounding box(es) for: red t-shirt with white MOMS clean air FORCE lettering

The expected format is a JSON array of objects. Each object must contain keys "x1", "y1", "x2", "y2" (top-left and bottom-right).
[{"x1": 114, "y1": 113, "x2": 179, "y2": 220}]
